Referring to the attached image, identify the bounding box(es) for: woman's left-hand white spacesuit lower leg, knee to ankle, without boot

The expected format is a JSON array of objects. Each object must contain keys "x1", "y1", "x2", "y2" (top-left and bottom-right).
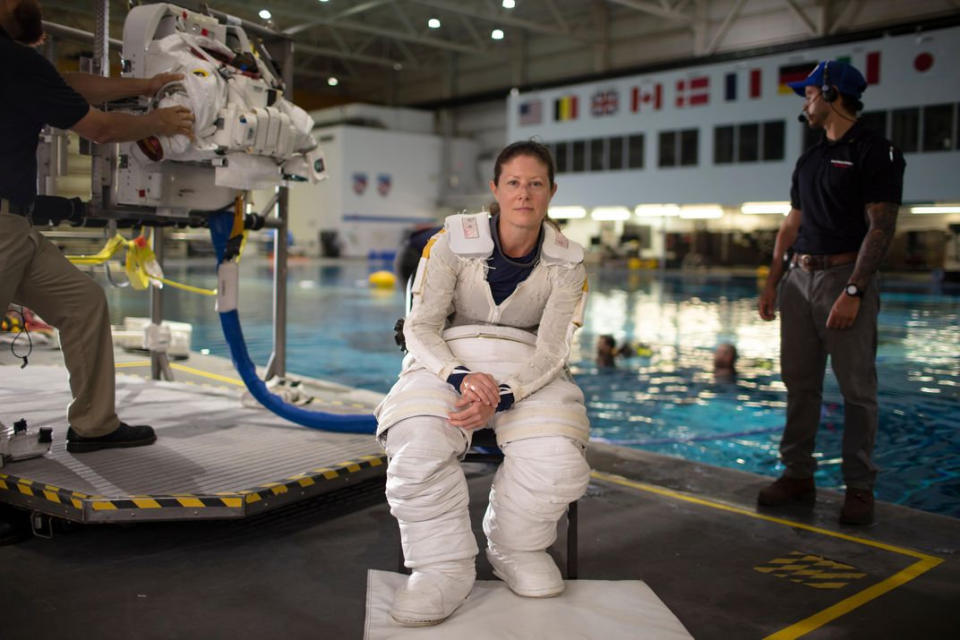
[{"x1": 386, "y1": 416, "x2": 477, "y2": 580}]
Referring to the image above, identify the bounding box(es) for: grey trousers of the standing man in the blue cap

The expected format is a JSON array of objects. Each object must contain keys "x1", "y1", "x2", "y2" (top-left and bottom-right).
[{"x1": 779, "y1": 263, "x2": 880, "y2": 489}]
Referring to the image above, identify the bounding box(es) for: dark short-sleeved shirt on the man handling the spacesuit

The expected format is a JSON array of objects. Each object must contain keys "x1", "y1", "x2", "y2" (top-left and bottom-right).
[{"x1": 0, "y1": 29, "x2": 90, "y2": 205}]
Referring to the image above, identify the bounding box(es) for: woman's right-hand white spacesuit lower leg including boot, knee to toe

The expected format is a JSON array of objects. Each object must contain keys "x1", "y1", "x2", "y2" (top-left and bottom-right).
[{"x1": 483, "y1": 436, "x2": 590, "y2": 598}]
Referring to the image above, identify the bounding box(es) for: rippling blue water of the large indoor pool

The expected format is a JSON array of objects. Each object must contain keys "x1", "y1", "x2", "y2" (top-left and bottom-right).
[{"x1": 99, "y1": 259, "x2": 960, "y2": 517}]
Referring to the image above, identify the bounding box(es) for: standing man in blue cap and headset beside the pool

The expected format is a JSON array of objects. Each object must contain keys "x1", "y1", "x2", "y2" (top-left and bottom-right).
[{"x1": 757, "y1": 62, "x2": 905, "y2": 524}]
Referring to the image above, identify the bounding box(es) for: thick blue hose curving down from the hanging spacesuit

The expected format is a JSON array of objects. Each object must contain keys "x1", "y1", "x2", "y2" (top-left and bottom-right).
[{"x1": 209, "y1": 211, "x2": 377, "y2": 434}]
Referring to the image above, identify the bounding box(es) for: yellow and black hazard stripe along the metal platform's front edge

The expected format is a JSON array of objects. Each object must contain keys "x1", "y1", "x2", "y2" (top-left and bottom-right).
[{"x1": 0, "y1": 455, "x2": 386, "y2": 512}]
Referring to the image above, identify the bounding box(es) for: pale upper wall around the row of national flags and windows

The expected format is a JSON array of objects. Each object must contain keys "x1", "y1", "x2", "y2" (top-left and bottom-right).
[{"x1": 507, "y1": 27, "x2": 960, "y2": 208}]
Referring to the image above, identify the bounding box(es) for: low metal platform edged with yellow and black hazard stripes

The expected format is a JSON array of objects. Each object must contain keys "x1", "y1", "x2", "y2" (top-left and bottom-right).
[{"x1": 0, "y1": 362, "x2": 386, "y2": 523}]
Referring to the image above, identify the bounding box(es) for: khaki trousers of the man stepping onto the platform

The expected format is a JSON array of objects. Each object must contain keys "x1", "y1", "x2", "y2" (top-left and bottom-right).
[{"x1": 0, "y1": 213, "x2": 120, "y2": 437}]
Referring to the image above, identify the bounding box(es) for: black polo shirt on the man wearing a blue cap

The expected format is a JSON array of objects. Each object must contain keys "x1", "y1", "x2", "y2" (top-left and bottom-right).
[{"x1": 790, "y1": 121, "x2": 906, "y2": 254}]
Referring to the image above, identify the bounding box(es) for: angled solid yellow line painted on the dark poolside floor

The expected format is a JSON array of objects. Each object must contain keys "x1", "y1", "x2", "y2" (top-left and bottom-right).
[{"x1": 590, "y1": 471, "x2": 943, "y2": 640}]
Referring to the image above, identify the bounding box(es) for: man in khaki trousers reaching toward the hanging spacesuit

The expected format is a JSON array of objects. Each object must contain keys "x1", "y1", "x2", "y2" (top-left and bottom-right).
[{"x1": 0, "y1": 0, "x2": 194, "y2": 468}]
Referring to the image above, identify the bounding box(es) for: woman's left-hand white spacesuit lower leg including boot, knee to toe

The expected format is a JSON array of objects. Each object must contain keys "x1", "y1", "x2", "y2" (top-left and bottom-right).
[{"x1": 386, "y1": 416, "x2": 477, "y2": 626}]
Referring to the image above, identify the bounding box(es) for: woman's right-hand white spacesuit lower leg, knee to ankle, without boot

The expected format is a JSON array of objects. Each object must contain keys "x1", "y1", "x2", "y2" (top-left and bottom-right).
[{"x1": 483, "y1": 436, "x2": 590, "y2": 551}]
